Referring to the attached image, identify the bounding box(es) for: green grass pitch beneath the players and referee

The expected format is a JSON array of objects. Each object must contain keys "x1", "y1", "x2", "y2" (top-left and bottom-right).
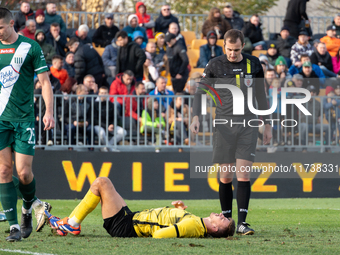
[{"x1": 0, "y1": 199, "x2": 340, "y2": 255}]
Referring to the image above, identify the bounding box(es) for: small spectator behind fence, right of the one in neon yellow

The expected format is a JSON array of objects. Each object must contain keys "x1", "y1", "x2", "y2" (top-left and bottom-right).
[{"x1": 168, "y1": 92, "x2": 189, "y2": 145}]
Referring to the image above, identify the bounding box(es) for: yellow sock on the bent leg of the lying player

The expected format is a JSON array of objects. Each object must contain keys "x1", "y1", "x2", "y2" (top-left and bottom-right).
[{"x1": 69, "y1": 189, "x2": 100, "y2": 224}]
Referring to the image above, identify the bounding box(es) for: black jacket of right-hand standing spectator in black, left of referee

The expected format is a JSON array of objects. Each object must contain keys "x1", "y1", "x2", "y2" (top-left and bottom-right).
[{"x1": 166, "y1": 42, "x2": 189, "y2": 78}]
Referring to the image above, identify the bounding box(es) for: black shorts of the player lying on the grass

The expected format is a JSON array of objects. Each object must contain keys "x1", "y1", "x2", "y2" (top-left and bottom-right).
[{"x1": 103, "y1": 206, "x2": 137, "y2": 237}]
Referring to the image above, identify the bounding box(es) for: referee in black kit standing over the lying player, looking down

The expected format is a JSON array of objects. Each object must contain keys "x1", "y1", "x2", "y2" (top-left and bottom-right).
[{"x1": 190, "y1": 29, "x2": 272, "y2": 235}]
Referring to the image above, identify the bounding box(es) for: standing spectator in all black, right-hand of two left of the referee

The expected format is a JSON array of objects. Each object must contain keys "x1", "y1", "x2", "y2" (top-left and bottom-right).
[{"x1": 165, "y1": 34, "x2": 189, "y2": 93}]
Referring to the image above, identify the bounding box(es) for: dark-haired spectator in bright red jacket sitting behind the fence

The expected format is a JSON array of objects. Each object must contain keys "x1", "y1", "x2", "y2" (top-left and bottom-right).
[{"x1": 110, "y1": 70, "x2": 136, "y2": 114}]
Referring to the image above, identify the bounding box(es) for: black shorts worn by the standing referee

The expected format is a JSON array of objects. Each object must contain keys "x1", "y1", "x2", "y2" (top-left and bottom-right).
[{"x1": 213, "y1": 116, "x2": 259, "y2": 164}]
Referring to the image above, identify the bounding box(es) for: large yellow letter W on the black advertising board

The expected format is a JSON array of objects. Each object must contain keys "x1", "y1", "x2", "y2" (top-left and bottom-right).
[{"x1": 62, "y1": 161, "x2": 112, "y2": 192}]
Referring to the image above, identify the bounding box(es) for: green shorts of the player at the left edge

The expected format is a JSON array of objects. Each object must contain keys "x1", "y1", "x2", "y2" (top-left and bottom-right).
[{"x1": 0, "y1": 121, "x2": 35, "y2": 156}]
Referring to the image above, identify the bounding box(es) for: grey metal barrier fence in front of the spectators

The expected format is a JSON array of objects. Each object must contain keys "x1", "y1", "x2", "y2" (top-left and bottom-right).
[{"x1": 35, "y1": 95, "x2": 340, "y2": 152}]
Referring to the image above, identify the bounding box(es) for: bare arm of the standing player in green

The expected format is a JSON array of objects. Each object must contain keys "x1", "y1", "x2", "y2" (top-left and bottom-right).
[{"x1": 38, "y1": 72, "x2": 55, "y2": 130}]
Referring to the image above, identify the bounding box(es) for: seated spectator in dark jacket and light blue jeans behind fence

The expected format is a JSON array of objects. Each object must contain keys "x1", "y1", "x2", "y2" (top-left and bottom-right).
[{"x1": 93, "y1": 86, "x2": 126, "y2": 151}]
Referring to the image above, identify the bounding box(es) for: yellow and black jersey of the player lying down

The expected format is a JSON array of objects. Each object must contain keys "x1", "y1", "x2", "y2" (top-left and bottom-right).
[{"x1": 132, "y1": 207, "x2": 207, "y2": 238}]
